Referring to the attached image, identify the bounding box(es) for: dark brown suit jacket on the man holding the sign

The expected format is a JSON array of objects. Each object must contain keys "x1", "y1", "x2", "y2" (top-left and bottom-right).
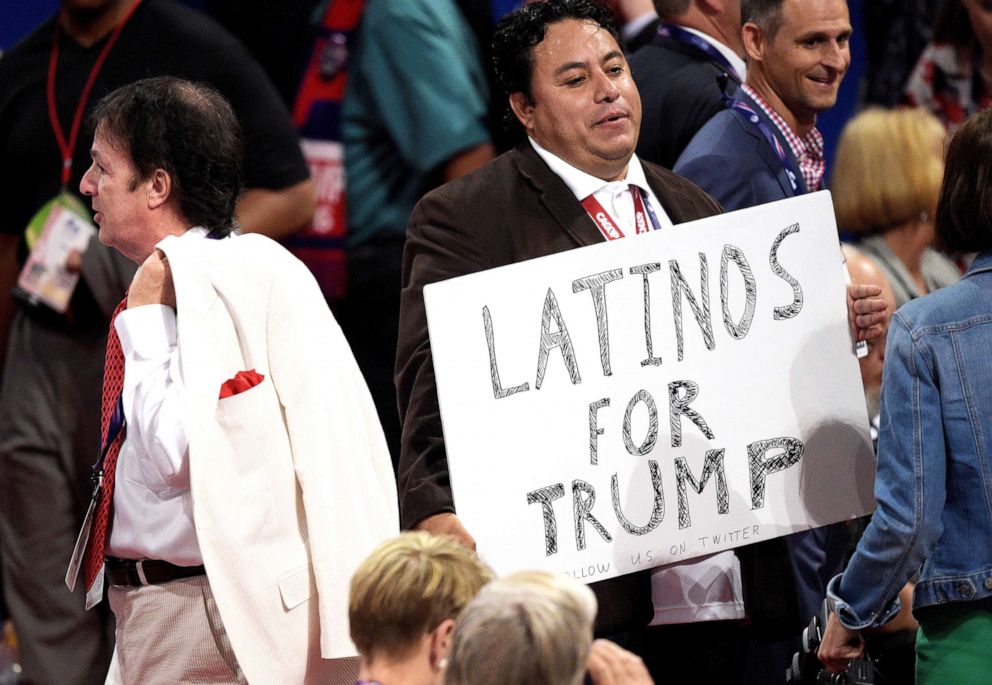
[{"x1": 396, "y1": 141, "x2": 722, "y2": 634}]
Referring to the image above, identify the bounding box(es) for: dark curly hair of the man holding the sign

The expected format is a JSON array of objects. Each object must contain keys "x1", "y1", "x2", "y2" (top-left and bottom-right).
[{"x1": 493, "y1": 0, "x2": 620, "y2": 104}]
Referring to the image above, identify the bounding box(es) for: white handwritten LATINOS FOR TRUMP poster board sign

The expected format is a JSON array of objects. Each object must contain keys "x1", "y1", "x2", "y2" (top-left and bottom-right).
[{"x1": 424, "y1": 192, "x2": 874, "y2": 581}]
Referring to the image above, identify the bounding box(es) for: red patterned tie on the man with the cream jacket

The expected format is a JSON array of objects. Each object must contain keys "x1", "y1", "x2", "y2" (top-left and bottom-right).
[{"x1": 83, "y1": 296, "x2": 127, "y2": 590}]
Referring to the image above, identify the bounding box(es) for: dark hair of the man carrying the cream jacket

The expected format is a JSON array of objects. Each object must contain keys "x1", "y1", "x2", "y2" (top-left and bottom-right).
[{"x1": 89, "y1": 76, "x2": 243, "y2": 236}]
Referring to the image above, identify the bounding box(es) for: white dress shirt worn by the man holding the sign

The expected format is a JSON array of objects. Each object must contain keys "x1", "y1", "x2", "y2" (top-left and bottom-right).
[{"x1": 529, "y1": 138, "x2": 744, "y2": 625}]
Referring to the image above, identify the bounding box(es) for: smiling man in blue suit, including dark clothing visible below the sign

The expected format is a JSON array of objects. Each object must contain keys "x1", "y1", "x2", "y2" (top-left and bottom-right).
[{"x1": 674, "y1": 0, "x2": 851, "y2": 685}]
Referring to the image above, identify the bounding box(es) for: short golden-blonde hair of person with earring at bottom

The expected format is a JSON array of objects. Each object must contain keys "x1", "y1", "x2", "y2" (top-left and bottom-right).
[{"x1": 348, "y1": 531, "x2": 493, "y2": 659}]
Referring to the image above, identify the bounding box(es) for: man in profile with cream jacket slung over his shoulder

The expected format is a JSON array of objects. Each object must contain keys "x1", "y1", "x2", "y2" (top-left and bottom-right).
[{"x1": 70, "y1": 78, "x2": 396, "y2": 683}]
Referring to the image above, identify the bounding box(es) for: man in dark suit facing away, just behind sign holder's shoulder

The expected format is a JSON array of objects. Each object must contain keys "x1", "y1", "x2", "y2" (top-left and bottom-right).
[{"x1": 630, "y1": 0, "x2": 746, "y2": 169}]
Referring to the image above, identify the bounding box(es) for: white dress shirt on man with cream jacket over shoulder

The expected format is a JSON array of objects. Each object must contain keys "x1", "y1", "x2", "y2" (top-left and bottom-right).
[{"x1": 107, "y1": 228, "x2": 207, "y2": 566}]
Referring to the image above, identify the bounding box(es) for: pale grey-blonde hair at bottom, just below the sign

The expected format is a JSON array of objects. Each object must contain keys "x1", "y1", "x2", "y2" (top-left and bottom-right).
[{"x1": 444, "y1": 571, "x2": 596, "y2": 685}]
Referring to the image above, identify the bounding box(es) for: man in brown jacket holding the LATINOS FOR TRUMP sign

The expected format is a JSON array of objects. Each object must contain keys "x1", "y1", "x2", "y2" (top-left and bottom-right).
[{"x1": 396, "y1": 0, "x2": 884, "y2": 682}]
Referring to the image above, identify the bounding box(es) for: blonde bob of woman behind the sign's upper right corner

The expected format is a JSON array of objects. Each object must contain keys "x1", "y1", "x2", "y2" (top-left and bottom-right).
[{"x1": 831, "y1": 108, "x2": 945, "y2": 233}]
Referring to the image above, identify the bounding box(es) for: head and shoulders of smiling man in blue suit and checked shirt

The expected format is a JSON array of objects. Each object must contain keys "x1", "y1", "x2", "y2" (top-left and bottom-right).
[{"x1": 675, "y1": 0, "x2": 851, "y2": 210}]
